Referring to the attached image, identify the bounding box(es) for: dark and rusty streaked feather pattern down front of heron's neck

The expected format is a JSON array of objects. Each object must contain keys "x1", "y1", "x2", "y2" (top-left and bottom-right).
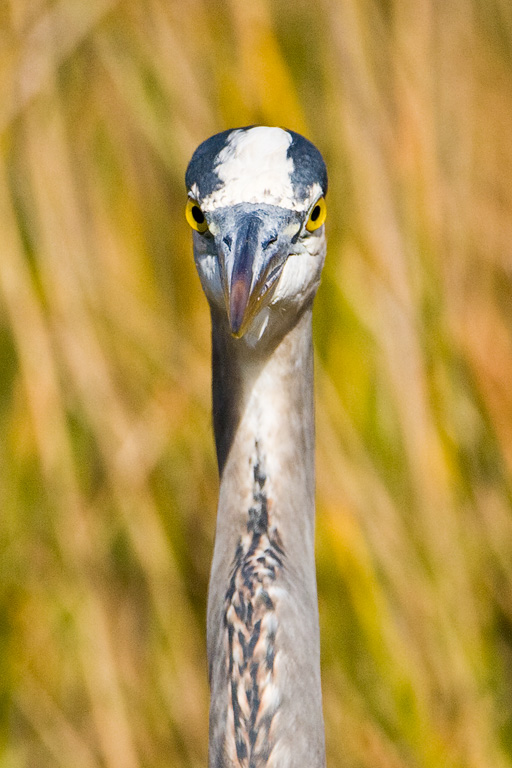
[{"x1": 224, "y1": 443, "x2": 284, "y2": 768}]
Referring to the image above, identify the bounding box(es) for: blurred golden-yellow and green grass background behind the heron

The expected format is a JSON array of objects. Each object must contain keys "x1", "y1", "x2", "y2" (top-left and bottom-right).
[{"x1": 0, "y1": 0, "x2": 512, "y2": 768}]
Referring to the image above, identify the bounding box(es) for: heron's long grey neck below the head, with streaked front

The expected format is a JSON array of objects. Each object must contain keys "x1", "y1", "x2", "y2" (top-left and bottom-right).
[{"x1": 208, "y1": 309, "x2": 325, "y2": 768}]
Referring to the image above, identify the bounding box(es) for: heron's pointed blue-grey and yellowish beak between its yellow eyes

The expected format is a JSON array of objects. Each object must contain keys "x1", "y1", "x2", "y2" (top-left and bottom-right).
[{"x1": 220, "y1": 209, "x2": 299, "y2": 338}]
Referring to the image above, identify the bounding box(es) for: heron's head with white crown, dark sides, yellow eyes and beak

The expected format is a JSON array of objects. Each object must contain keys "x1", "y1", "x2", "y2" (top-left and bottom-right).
[{"x1": 186, "y1": 126, "x2": 327, "y2": 346}]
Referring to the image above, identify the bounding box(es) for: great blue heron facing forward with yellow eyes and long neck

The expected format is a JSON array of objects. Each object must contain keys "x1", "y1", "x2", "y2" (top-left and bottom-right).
[{"x1": 186, "y1": 126, "x2": 327, "y2": 768}]
